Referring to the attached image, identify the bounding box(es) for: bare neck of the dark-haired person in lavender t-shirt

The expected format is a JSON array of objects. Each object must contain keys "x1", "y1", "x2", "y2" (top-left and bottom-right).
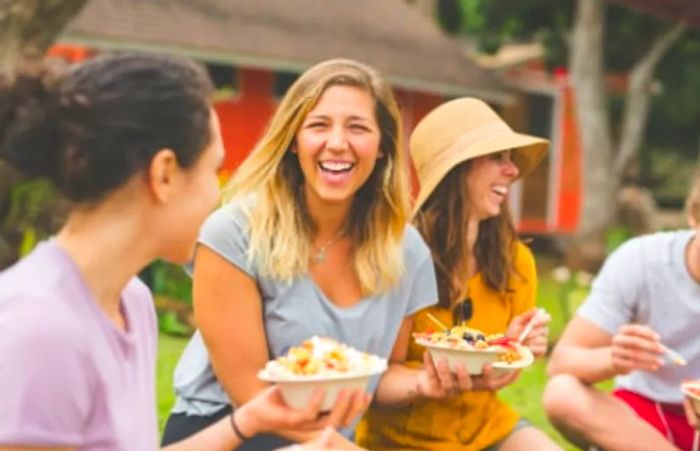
[{"x1": 56, "y1": 198, "x2": 156, "y2": 329}]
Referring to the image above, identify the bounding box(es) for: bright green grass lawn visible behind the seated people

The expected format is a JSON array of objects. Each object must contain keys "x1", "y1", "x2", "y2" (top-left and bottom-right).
[{"x1": 157, "y1": 275, "x2": 585, "y2": 450}]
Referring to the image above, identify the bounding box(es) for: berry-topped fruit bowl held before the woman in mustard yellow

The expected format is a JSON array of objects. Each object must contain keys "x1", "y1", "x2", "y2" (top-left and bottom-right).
[{"x1": 413, "y1": 326, "x2": 534, "y2": 375}]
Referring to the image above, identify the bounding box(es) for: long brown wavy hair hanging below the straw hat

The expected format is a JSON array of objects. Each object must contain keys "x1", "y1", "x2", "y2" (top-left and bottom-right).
[{"x1": 414, "y1": 161, "x2": 517, "y2": 308}]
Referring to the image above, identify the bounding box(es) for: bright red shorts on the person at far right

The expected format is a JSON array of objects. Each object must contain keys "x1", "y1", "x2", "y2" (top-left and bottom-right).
[{"x1": 613, "y1": 389, "x2": 695, "y2": 451}]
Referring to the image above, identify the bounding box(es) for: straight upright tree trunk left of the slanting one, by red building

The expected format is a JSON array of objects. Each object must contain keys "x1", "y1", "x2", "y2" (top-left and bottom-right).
[{"x1": 570, "y1": 0, "x2": 615, "y2": 251}]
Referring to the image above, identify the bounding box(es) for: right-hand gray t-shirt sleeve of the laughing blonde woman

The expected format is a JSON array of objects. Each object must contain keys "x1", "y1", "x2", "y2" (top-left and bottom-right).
[{"x1": 404, "y1": 227, "x2": 438, "y2": 316}]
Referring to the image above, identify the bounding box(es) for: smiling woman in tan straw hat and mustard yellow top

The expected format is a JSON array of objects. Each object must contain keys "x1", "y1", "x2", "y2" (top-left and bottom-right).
[{"x1": 358, "y1": 98, "x2": 557, "y2": 451}]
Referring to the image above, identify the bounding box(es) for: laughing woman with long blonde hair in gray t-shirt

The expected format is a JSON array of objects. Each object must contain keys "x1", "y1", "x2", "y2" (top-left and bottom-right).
[{"x1": 164, "y1": 60, "x2": 448, "y2": 450}]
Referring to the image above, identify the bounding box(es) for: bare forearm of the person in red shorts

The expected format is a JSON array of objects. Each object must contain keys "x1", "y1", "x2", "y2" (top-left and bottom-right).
[{"x1": 547, "y1": 345, "x2": 617, "y2": 384}]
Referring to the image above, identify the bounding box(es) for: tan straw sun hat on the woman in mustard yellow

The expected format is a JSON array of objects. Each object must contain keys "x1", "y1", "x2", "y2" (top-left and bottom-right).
[{"x1": 410, "y1": 98, "x2": 549, "y2": 211}]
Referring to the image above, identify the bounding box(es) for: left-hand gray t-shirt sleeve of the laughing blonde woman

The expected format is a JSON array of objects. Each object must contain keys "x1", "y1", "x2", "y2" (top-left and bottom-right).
[{"x1": 194, "y1": 205, "x2": 257, "y2": 278}]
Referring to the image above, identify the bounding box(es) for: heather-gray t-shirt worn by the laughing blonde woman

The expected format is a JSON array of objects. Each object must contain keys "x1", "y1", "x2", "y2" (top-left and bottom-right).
[{"x1": 173, "y1": 205, "x2": 438, "y2": 426}]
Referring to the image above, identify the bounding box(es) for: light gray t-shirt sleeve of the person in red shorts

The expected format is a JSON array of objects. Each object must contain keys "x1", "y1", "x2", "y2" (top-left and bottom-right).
[{"x1": 577, "y1": 239, "x2": 643, "y2": 334}]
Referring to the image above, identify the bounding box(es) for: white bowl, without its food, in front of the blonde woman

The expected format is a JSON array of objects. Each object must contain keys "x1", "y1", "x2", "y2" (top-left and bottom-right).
[{"x1": 258, "y1": 359, "x2": 387, "y2": 411}]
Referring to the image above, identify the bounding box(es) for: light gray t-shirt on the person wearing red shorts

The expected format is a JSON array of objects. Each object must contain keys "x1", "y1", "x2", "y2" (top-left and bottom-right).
[{"x1": 578, "y1": 230, "x2": 700, "y2": 403}]
